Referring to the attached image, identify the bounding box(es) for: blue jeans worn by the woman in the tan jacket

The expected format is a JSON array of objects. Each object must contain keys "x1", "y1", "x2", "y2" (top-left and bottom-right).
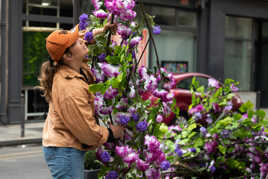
[{"x1": 43, "y1": 147, "x2": 85, "y2": 179}]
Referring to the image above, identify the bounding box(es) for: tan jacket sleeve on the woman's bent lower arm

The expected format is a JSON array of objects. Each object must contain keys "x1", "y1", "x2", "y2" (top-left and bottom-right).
[{"x1": 58, "y1": 96, "x2": 109, "y2": 146}]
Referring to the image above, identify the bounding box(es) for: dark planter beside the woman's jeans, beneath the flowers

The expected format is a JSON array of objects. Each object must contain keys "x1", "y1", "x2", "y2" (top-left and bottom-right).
[{"x1": 84, "y1": 150, "x2": 101, "y2": 179}]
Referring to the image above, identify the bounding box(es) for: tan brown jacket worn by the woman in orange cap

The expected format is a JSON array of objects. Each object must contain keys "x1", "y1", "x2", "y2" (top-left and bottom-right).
[{"x1": 43, "y1": 64, "x2": 109, "y2": 150}]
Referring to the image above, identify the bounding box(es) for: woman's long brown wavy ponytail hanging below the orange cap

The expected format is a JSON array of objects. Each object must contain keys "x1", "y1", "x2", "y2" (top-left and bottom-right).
[{"x1": 37, "y1": 58, "x2": 62, "y2": 102}]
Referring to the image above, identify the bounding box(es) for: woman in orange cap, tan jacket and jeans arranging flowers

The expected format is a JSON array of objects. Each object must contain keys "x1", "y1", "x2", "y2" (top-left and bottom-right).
[{"x1": 39, "y1": 24, "x2": 124, "y2": 179}]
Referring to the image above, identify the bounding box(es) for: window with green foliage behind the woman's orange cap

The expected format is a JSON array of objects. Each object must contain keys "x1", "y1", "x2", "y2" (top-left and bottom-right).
[{"x1": 23, "y1": 0, "x2": 73, "y2": 120}]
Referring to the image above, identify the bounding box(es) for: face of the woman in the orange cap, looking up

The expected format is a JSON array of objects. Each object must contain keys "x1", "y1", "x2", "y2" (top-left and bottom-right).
[{"x1": 70, "y1": 38, "x2": 88, "y2": 60}]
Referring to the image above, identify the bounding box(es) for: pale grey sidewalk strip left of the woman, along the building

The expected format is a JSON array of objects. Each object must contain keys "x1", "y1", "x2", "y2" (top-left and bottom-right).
[{"x1": 0, "y1": 122, "x2": 44, "y2": 147}]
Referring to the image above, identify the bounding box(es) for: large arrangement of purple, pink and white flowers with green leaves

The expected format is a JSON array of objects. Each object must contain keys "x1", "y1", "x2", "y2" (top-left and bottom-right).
[{"x1": 79, "y1": 0, "x2": 268, "y2": 179}]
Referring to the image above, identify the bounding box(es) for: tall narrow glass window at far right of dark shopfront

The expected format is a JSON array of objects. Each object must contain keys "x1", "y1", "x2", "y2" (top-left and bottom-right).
[{"x1": 224, "y1": 17, "x2": 253, "y2": 91}]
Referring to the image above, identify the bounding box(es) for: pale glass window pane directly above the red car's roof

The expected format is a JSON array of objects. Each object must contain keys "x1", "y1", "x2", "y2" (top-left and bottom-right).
[{"x1": 151, "y1": 29, "x2": 196, "y2": 72}]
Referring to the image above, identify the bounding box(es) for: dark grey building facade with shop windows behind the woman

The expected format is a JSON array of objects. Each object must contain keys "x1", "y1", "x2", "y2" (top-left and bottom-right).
[{"x1": 0, "y1": 0, "x2": 268, "y2": 124}]
